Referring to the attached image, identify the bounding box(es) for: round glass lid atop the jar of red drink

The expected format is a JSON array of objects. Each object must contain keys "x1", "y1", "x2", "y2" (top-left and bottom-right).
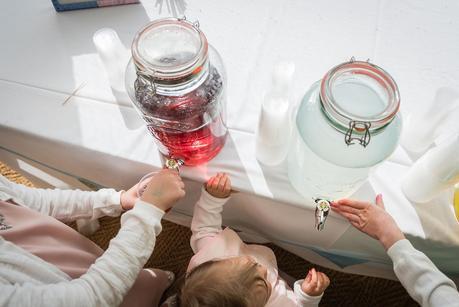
[{"x1": 131, "y1": 18, "x2": 208, "y2": 81}]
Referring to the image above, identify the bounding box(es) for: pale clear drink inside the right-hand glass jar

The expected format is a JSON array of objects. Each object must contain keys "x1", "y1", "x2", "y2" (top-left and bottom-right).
[{"x1": 288, "y1": 62, "x2": 401, "y2": 200}]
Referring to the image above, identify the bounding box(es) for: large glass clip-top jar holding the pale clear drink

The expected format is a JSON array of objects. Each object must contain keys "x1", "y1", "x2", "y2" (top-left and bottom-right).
[{"x1": 288, "y1": 60, "x2": 401, "y2": 199}]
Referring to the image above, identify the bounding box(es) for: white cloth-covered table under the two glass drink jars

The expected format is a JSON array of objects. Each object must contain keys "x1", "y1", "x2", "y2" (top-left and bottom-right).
[{"x1": 0, "y1": 0, "x2": 459, "y2": 278}]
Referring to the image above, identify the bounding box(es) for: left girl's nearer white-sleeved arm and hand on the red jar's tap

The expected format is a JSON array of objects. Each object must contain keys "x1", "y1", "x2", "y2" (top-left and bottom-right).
[{"x1": 0, "y1": 170, "x2": 185, "y2": 307}]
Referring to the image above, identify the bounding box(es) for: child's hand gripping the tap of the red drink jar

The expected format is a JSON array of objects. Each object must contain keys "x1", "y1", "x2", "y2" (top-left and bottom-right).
[{"x1": 140, "y1": 169, "x2": 185, "y2": 211}]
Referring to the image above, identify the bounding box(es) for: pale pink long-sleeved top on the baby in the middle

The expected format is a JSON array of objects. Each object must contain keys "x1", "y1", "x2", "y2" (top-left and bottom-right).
[{"x1": 188, "y1": 188, "x2": 323, "y2": 307}]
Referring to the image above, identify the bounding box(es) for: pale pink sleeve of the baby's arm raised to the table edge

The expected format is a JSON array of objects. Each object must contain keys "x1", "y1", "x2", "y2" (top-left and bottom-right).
[{"x1": 190, "y1": 188, "x2": 229, "y2": 254}]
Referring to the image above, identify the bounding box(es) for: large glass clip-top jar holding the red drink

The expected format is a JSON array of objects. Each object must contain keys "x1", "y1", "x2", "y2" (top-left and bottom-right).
[{"x1": 126, "y1": 18, "x2": 227, "y2": 165}]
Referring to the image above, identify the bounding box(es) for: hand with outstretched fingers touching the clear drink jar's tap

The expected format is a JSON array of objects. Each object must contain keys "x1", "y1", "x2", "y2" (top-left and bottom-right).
[{"x1": 331, "y1": 194, "x2": 405, "y2": 250}]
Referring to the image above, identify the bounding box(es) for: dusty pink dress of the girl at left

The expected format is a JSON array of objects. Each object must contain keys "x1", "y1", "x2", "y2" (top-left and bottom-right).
[{"x1": 0, "y1": 201, "x2": 167, "y2": 306}]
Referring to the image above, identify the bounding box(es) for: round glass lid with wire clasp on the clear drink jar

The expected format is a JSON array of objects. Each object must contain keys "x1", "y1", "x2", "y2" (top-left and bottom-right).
[{"x1": 320, "y1": 58, "x2": 400, "y2": 146}]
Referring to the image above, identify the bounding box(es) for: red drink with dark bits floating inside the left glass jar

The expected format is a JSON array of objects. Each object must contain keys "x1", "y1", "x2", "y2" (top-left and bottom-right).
[{"x1": 137, "y1": 67, "x2": 227, "y2": 165}]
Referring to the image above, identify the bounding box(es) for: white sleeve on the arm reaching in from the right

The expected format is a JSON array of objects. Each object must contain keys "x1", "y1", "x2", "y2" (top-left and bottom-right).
[{"x1": 387, "y1": 239, "x2": 459, "y2": 306}]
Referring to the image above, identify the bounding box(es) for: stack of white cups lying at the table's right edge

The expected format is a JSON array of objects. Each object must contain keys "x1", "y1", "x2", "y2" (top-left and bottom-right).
[{"x1": 402, "y1": 135, "x2": 459, "y2": 203}]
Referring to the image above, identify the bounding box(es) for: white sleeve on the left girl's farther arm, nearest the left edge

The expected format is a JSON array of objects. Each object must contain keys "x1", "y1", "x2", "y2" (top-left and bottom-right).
[{"x1": 0, "y1": 177, "x2": 122, "y2": 221}]
